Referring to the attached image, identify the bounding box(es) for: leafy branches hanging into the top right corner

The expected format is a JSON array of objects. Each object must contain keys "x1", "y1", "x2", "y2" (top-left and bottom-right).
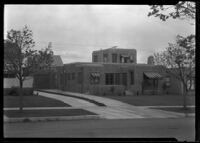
[{"x1": 148, "y1": 1, "x2": 196, "y2": 21}]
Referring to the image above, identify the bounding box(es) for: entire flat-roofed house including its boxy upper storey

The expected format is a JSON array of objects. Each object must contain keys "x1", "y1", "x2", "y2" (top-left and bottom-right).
[{"x1": 53, "y1": 47, "x2": 173, "y2": 95}]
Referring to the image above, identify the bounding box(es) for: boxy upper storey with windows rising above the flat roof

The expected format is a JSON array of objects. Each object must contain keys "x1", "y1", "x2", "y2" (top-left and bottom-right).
[{"x1": 92, "y1": 46, "x2": 137, "y2": 64}]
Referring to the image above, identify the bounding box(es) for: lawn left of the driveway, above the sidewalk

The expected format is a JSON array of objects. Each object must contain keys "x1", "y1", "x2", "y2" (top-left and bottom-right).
[{"x1": 4, "y1": 96, "x2": 70, "y2": 108}]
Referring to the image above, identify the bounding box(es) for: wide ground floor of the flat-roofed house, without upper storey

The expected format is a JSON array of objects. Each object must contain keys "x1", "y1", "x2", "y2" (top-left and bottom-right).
[{"x1": 56, "y1": 63, "x2": 166, "y2": 95}]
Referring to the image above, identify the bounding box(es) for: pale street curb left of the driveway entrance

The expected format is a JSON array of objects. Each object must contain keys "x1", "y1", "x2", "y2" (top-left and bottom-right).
[{"x1": 4, "y1": 115, "x2": 101, "y2": 123}]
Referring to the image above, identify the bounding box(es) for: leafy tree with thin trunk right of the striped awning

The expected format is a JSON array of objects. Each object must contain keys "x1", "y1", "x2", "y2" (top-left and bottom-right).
[{"x1": 154, "y1": 34, "x2": 195, "y2": 109}]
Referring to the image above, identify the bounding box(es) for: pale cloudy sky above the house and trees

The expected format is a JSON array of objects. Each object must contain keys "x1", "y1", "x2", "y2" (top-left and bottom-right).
[{"x1": 4, "y1": 5, "x2": 195, "y2": 63}]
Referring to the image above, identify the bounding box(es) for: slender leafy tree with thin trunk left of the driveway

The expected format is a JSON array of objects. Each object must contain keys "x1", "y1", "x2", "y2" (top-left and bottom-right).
[{"x1": 4, "y1": 26, "x2": 52, "y2": 111}]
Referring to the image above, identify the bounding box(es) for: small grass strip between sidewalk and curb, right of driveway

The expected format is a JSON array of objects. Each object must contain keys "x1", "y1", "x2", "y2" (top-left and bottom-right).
[{"x1": 152, "y1": 107, "x2": 195, "y2": 113}]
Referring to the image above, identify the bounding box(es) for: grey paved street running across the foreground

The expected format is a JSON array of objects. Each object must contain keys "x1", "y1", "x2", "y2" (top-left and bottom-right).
[{"x1": 4, "y1": 117, "x2": 195, "y2": 141}]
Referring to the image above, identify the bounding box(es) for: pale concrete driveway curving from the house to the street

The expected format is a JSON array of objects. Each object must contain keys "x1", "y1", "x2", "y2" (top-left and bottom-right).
[{"x1": 38, "y1": 90, "x2": 188, "y2": 119}]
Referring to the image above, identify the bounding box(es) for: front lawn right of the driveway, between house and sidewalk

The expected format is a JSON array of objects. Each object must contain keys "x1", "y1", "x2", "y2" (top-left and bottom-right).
[{"x1": 105, "y1": 95, "x2": 195, "y2": 106}]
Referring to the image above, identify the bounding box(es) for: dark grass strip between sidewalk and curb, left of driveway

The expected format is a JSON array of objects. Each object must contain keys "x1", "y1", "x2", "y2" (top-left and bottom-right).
[{"x1": 4, "y1": 109, "x2": 96, "y2": 118}]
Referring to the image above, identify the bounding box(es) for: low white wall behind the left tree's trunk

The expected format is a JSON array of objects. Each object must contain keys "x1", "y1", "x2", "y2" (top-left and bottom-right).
[{"x1": 3, "y1": 77, "x2": 33, "y2": 88}]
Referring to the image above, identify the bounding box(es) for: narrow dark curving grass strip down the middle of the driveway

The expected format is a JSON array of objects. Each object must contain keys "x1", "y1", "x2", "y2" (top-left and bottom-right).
[{"x1": 38, "y1": 90, "x2": 106, "y2": 106}]
